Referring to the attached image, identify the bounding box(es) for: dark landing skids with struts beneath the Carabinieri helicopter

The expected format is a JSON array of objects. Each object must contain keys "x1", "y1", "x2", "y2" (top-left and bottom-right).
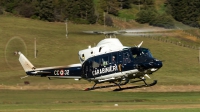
[{"x1": 85, "y1": 79, "x2": 157, "y2": 91}]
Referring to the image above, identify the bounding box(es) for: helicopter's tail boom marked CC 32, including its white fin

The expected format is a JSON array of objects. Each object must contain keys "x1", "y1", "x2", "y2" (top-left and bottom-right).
[{"x1": 17, "y1": 52, "x2": 81, "y2": 79}]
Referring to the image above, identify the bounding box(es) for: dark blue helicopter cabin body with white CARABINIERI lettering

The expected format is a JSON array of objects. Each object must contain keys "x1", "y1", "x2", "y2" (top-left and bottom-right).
[{"x1": 81, "y1": 47, "x2": 162, "y2": 83}]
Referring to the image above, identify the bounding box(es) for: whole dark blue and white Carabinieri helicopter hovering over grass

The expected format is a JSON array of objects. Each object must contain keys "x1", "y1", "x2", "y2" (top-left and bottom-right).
[{"x1": 15, "y1": 32, "x2": 163, "y2": 91}]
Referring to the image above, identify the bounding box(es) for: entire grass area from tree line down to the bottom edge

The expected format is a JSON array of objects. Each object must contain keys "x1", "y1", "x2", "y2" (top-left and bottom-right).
[{"x1": 0, "y1": 15, "x2": 200, "y2": 112}]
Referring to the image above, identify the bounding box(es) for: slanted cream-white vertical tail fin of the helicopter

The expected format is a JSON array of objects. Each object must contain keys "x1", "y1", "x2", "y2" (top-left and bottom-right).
[{"x1": 18, "y1": 52, "x2": 35, "y2": 72}]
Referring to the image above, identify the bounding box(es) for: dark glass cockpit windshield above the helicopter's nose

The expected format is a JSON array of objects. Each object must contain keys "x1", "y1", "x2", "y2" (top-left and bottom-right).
[{"x1": 131, "y1": 47, "x2": 153, "y2": 58}]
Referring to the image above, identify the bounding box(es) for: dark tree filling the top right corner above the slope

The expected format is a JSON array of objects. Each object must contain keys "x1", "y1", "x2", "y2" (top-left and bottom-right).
[{"x1": 166, "y1": 0, "x2": 200, "y2": 27}]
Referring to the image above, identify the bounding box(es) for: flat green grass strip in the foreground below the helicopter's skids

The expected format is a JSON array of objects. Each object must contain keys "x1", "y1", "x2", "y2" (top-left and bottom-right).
[{"x1": 0, "y1": 90, "x2": 200, "y2": 112}]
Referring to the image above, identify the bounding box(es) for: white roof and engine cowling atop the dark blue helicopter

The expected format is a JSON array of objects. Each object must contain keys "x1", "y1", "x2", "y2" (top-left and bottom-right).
[{"x1": 78, "y1": 38, "x2": 127, "y2": 63}]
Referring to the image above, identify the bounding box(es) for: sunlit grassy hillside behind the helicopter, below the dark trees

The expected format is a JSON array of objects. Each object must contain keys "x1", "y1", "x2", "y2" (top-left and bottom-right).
[{"x1": 0, "y1": 15, "x2": 200, "y2": 91}]
